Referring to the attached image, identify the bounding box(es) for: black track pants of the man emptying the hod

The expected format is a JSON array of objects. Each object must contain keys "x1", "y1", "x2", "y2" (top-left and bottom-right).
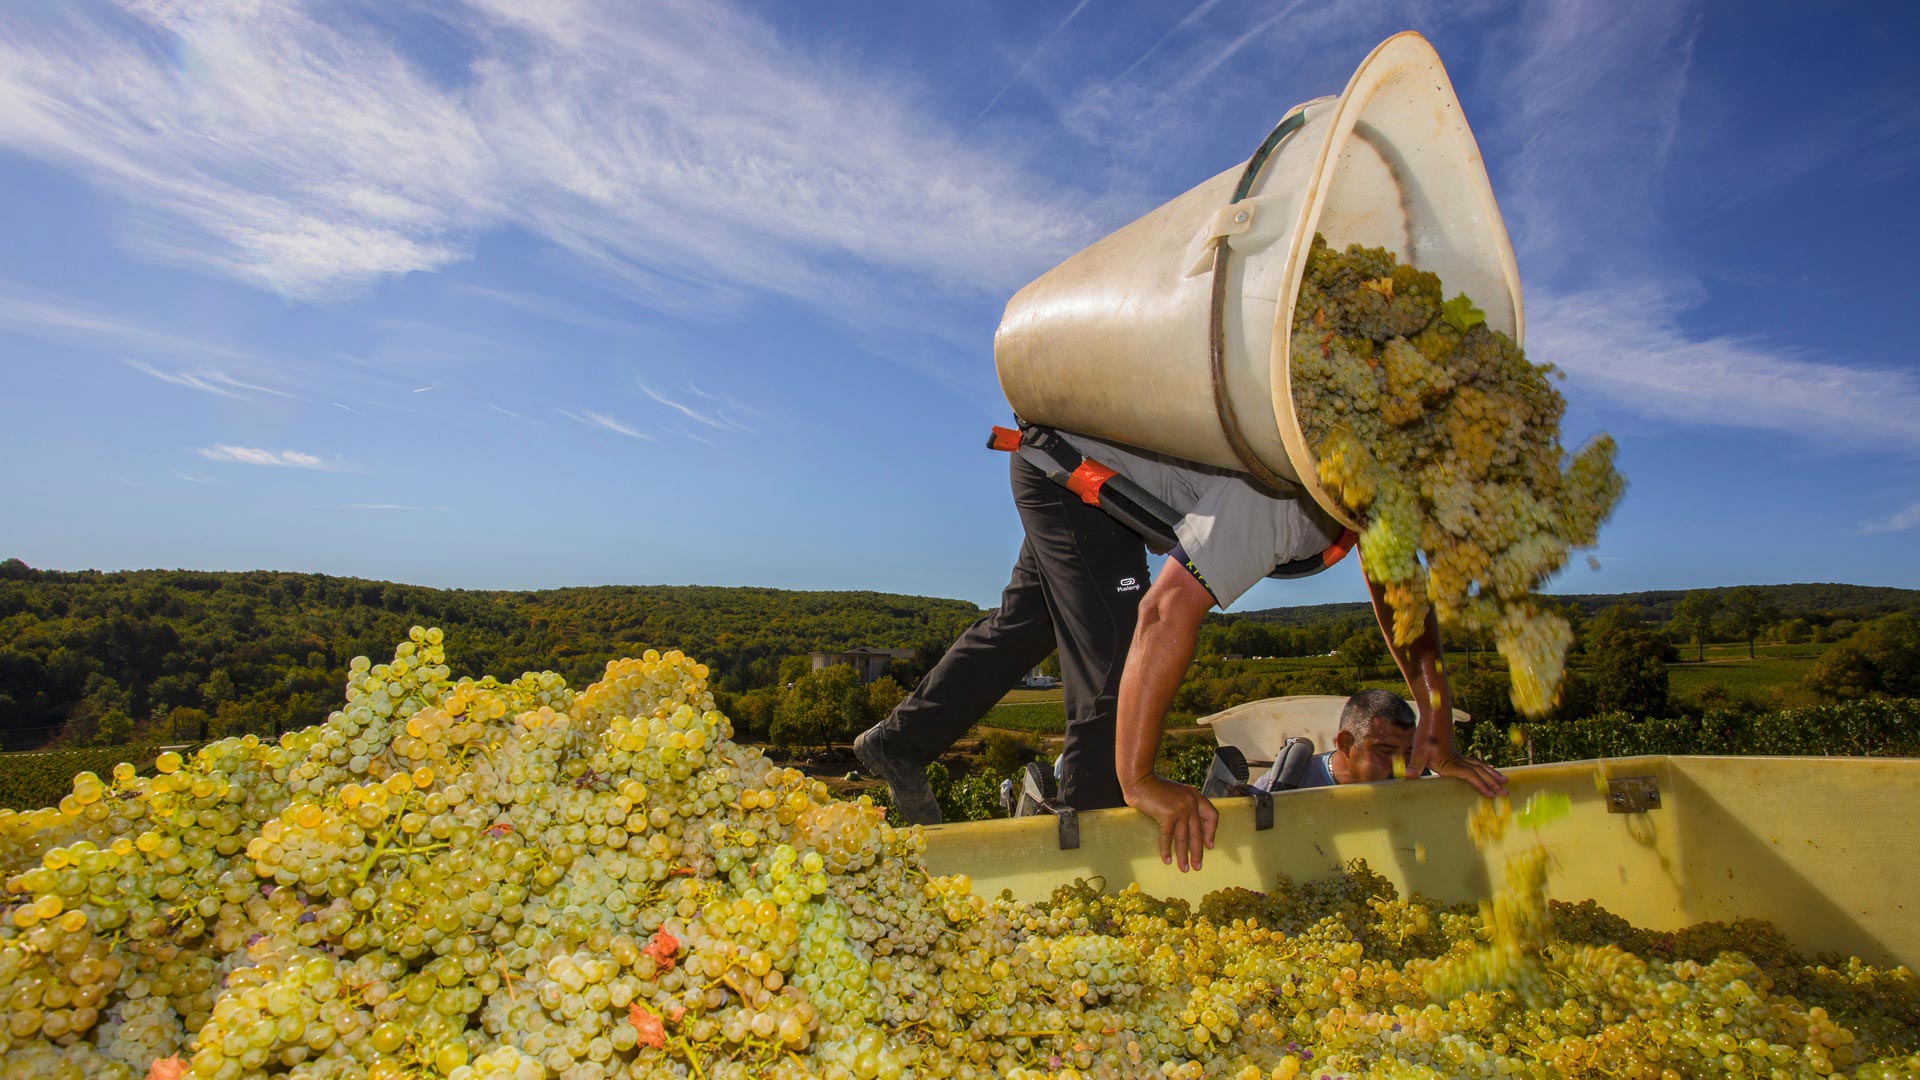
[{"x1": 881, "y1": 454, "x2": 1146, "y2": 809}]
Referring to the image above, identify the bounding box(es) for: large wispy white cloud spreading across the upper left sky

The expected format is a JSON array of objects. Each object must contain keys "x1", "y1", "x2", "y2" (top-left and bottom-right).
[{"x1": 0, "y1": 0, "x2": 1100, "y2": 317}]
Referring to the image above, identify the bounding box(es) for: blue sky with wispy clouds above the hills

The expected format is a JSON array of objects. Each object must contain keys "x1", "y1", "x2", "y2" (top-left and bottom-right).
[{"x1": 0, "y1": 0, "x2": 1920, "y2": 609}]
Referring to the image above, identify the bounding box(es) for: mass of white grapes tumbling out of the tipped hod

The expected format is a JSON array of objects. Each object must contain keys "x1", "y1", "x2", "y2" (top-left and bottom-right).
[{"x1": 1292, "y1": 236, "x2": 1624, "y2": 717}]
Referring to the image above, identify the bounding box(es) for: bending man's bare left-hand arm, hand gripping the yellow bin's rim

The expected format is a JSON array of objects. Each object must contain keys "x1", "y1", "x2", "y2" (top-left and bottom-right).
[{"x1": 1114, "y1": 559, "x2": 1219, "y2": 872}]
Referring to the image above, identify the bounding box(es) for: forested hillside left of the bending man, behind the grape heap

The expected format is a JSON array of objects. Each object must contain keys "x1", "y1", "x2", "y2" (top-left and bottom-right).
[{"x1": 0, "y1": 559, "x2": 979, "y2": 749}]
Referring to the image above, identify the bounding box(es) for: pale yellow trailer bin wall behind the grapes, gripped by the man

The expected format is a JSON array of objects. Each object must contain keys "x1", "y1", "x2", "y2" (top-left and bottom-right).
[{"x1": 927, "y1": 757, "x2": 1920, "y2": 967}]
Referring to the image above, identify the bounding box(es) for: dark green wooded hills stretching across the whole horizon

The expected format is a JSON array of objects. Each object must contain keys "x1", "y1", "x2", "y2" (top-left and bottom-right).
[{"x1": 0, "y1": 559, "x2": 1920, "y2": 749}]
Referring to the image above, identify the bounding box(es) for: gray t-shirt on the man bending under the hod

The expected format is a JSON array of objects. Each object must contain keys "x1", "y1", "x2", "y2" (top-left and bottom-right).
[{"x1": 1062, "y1": 432, "x2": 1340, "y2": 611}]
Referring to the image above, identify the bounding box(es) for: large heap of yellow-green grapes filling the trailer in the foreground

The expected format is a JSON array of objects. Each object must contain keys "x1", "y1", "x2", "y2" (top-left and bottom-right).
[{"x1": 0, "y1": 628, "x2": 1920, "y2": 1080}]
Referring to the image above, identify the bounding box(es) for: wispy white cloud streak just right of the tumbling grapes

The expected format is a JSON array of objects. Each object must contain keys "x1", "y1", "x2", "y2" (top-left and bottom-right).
[{"x1": 1526, "y1": 288, "x2": 1920, "y2": 454}]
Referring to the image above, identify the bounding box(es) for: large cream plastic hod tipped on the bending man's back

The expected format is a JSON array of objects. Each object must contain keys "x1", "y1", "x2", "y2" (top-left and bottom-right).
[{"x1": 993, "y1": 31, "x2": 1523, "y2": 525}]
